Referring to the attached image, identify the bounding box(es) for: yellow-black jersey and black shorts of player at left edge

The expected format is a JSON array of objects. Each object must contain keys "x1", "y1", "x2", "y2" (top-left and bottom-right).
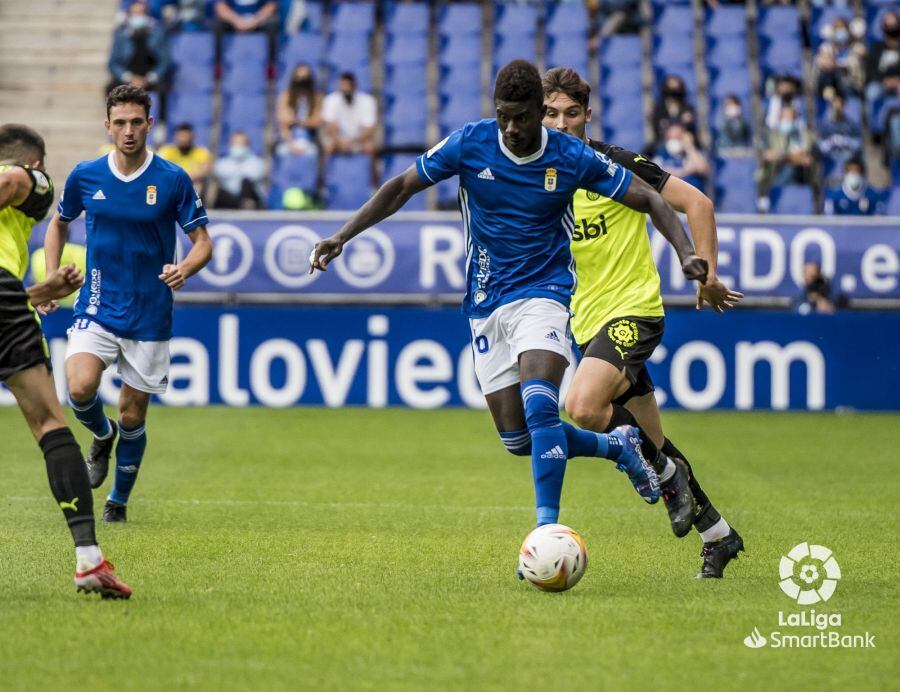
[{"x1": 0, "y1": 165, "x2": 53, "y2": 381}]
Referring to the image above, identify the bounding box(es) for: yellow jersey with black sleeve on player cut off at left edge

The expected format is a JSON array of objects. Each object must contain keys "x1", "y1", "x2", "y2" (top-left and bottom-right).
[{"x1": 0, "y1": 164, "x2": 53, "y2": 280}]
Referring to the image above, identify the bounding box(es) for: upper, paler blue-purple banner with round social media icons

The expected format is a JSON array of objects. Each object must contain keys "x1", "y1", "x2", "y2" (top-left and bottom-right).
[{"x1": 32, "y1": 212, "x2": 900, "y2": 300}]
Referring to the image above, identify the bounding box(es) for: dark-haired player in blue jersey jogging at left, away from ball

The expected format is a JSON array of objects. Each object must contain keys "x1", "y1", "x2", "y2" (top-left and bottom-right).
[{"x1": 43, "y1": 85, "x2": 212, "y2": 521}]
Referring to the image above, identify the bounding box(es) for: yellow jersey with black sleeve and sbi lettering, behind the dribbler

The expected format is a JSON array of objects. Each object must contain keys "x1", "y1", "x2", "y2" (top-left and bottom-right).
[{"x1": 572, "y1": 140, "x2": 669, "y2": 345}]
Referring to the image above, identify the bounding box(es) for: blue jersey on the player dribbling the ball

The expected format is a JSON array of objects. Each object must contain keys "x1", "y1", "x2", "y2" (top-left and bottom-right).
[{"x1": 416, "y1": 119, "x2": 631, "y2": 317}]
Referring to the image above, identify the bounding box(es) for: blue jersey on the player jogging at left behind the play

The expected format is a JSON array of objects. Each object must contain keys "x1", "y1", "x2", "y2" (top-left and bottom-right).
[{"x1": 58, "y1": 152, "x2": 207, "y2": 341}]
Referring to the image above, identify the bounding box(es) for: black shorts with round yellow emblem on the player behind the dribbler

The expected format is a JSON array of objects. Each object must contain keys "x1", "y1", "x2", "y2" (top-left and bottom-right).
[{"x1": 581, "y1": 317, "x2": 665, "y2": 404}]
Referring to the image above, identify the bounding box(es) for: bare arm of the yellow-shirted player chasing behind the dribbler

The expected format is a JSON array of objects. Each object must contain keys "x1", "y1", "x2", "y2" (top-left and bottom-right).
[{"x1": 662, "y1": 175, "x2": 744, "y2": 314}]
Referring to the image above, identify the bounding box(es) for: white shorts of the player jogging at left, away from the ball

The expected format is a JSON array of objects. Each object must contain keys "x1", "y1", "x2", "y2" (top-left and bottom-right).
[{"x1": 66, "y1": 319, "x2": 170, "y2": 394}]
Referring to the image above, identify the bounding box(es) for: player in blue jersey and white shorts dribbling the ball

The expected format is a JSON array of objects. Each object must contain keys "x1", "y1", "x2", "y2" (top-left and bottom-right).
[{"x1": 310, "y1": 60, "x2": 707, "y2": 525}]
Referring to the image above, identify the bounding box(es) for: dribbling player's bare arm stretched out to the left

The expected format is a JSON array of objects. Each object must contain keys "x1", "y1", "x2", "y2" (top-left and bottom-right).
[{"x1": 309, "y1": 165, "x2": 428, "y2": 274}]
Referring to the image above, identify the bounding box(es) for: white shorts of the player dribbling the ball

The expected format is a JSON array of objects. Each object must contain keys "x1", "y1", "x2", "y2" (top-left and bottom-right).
[{"x1": 469, "y1": 298, "x2": 572, "y2": 394}]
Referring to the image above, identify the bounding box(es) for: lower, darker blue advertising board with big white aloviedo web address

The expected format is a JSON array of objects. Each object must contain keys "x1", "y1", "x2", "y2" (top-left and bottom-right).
[{"x1": 14, "y1": 306, "x2": 900, "y2": 411}]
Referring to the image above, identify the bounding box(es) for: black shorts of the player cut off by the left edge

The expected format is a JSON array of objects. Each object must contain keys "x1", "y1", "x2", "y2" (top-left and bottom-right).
[{"x1": 0, "y1": 269, "x2": 50, "y2": 382}]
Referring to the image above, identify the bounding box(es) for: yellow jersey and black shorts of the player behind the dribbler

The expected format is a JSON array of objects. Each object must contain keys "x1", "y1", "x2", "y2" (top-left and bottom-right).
[{"x1": 572, "y1": 140, "x2": 669, "y2": 403}]
